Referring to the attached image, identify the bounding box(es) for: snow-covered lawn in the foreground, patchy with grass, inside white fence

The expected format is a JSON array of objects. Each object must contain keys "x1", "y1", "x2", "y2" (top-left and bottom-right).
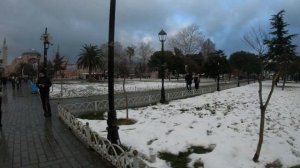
[{"x1": 78, "y1": 82, "x2": 300, "y2": 168}]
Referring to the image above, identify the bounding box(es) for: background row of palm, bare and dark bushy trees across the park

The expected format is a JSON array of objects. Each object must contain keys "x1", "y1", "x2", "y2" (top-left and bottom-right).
[{"x1": 77, "y1": 19, "x2": 300, "y2": 86}]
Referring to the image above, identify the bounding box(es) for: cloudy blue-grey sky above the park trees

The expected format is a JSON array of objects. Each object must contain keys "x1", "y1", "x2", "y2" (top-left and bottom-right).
[{"x1": 0, "y1": 0, "x2": 300, "y2": 62}]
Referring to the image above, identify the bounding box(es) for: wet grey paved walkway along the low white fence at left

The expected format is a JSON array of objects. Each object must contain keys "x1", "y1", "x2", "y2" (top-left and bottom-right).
[{"x1": 0, "y1": 83, "x2": 111, "y2": 168}]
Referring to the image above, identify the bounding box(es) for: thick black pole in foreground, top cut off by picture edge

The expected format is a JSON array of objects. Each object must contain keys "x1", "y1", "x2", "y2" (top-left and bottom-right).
[{"x1": 106, "y1": 0, "x2": 120, "y2": 144}]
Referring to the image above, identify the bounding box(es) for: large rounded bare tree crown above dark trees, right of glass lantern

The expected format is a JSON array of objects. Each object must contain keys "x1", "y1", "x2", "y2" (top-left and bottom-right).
[{"x1": 168, "y1": 24, "x2": 205, "y2": 55}]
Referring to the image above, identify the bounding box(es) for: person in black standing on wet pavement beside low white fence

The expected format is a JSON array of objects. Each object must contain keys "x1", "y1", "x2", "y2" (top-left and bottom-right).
[{"x1": 36, "y1": 70, "x2": 52, "y2": 117}]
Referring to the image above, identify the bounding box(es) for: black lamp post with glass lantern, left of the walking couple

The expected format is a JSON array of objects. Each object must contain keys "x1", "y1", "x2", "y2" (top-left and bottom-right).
[{"x1": 158, "y1": 30, "x2": 167, "y2": 103}]
